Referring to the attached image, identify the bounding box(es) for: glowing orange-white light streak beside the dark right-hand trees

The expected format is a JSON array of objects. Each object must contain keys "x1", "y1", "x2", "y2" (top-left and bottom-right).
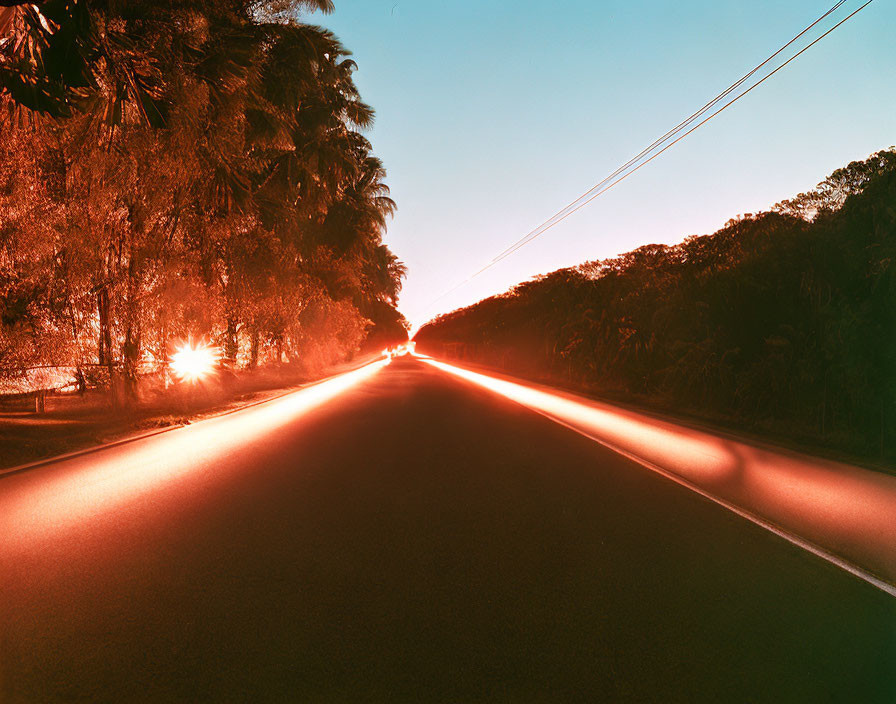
[{"x1": 420, "y1": 356, "x2": 896, "y2": 596}]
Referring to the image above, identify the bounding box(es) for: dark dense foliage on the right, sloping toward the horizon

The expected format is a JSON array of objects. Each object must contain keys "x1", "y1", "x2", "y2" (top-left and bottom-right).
[{"x1": 416, "y1": 151, "x2": 896, "y2": 461}]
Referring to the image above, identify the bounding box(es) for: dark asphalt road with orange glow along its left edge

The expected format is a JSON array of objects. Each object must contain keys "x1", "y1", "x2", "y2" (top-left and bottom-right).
[{"x1": 0, "y1": 358, "x2": 896, "y2": 703}]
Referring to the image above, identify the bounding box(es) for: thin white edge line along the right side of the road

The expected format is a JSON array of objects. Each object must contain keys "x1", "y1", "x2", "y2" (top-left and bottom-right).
[{"x1": 420, "y1": 357, "x2": 896, "y2": 597}]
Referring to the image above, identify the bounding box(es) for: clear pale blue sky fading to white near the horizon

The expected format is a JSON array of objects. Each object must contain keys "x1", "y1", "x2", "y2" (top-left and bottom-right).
[{"x1": 307, "y1": 0, "x2": 896, "y2": 325}]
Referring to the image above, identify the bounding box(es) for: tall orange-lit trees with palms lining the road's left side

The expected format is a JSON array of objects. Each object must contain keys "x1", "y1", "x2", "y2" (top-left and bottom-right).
[{"x1": 0, "y1": 0, "x2": 407, "y2": 398}]
